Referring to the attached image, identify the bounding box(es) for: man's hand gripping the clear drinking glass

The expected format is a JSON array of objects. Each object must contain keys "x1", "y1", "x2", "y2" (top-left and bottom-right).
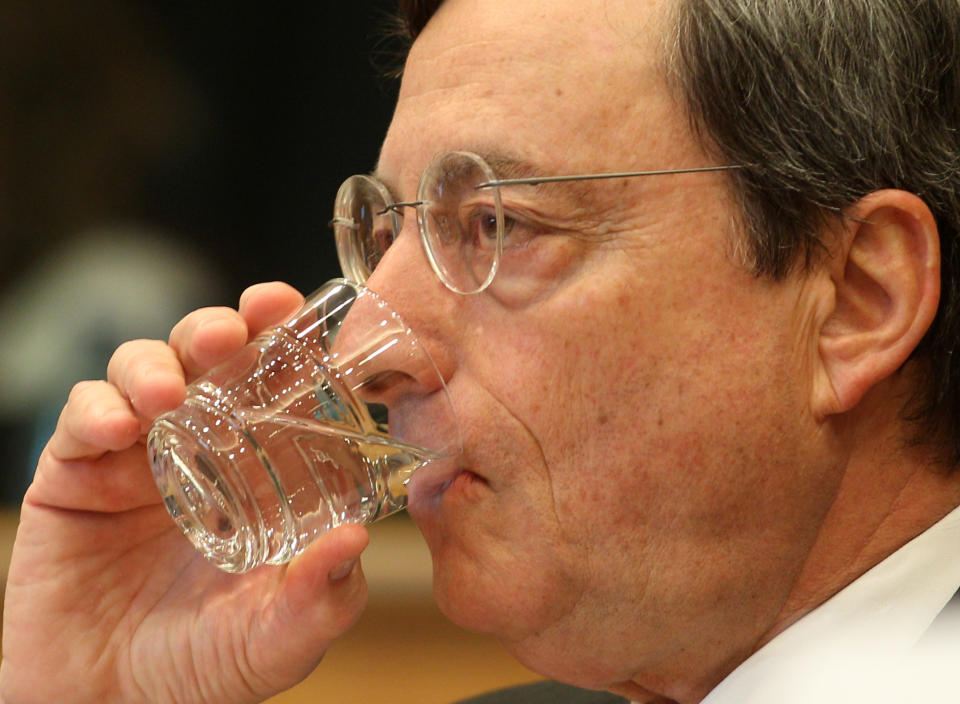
[{"x1": 0, "y1": 284, "x2": 367, "y2": 704}]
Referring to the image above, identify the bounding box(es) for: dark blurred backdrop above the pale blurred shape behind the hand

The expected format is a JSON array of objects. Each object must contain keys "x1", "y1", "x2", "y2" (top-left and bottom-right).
[{"x1": 0, "y1": 0, "x2": 394, "y2": 296}]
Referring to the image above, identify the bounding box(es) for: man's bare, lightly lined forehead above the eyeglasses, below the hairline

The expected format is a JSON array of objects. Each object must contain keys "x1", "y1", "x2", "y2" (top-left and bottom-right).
[{"x1": 380, "y1": 0, "x2": 702, "y2": 183}]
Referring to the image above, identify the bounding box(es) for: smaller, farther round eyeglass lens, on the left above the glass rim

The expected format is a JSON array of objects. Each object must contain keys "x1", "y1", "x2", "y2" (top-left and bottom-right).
[{"x1": 333, "y1": 175, "x2": 401, "y2": 283}]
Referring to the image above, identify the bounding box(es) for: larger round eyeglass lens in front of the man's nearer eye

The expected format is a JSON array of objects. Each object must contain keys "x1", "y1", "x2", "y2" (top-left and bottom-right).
[{"x1": 417, "y1": 152, "x2": 503, "y2": 293}]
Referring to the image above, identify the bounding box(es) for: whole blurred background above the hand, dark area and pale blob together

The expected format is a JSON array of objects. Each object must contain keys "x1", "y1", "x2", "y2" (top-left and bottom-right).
[{"x1": 0, "y1": 0, "x2": 398, "y2": 505}]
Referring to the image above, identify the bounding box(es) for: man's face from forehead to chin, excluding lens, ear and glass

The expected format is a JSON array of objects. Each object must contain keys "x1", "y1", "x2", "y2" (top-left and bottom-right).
[{"x1": 369, "y1": 0, "x2": 833, "y2": 691}]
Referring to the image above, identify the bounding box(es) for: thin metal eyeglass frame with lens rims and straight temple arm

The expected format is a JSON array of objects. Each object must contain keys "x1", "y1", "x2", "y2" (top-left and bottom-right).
[{"x1": 329, "y1": 152, "x2": 746, "y2": 295}]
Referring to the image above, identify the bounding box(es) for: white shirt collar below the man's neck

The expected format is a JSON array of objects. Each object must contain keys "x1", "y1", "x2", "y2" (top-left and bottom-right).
[{"x1": 702, "y1": 507, "x2": 960, "y2": 704}]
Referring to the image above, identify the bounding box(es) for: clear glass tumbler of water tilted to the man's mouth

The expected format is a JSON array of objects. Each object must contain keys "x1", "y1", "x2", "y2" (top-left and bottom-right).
[{"x1": 147, "y1": 279, "x2": 460, "y2": 572}]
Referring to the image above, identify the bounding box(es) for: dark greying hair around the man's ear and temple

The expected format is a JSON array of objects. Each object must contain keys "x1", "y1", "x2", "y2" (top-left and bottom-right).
[{"x1": 668, "y1": 0, "x2": 960, "y2": 465}]
